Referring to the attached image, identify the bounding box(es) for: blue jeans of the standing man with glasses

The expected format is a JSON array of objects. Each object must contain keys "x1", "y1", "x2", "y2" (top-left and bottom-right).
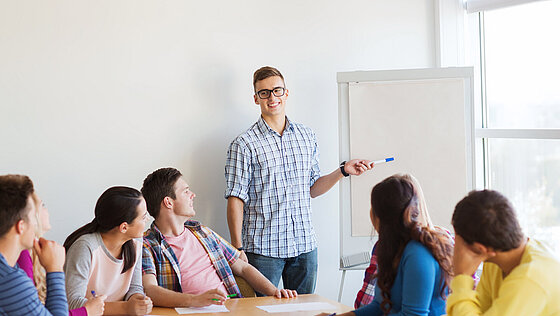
[{"x1": 246, "y1": 249, "x2": 317, "y2": 296}]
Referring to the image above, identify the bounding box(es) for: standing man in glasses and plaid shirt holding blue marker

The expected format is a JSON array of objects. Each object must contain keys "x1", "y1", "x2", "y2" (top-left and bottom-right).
[{"x1": 225, "y1": 67, "x2": 373, "y2": 294}]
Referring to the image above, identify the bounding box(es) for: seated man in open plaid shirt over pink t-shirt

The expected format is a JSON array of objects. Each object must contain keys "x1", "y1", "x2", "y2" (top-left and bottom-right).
[{"x1": 142, "y1": 168, "x2": 297, "y2": 307}]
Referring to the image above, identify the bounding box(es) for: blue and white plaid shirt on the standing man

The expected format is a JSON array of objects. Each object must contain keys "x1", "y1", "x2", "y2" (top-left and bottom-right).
[{"x1": 224, "y1": 117, "x2": 320, "y2": 258}]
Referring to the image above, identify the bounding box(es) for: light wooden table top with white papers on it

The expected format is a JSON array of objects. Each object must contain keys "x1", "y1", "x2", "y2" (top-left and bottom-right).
[{"x1": 150, "y1": 294, "x2": 353, "y2": 316}]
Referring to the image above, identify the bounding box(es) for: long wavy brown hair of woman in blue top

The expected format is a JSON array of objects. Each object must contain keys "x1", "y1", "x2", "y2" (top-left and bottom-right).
[{"x1": 371, "y1": 175, "x2": 453, "y2": 314}]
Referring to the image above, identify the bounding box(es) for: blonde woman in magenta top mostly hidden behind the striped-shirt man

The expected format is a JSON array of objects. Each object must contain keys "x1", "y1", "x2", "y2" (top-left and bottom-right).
[{"x1": 17, "y1": 193, "x2": 105, "y2": 316}]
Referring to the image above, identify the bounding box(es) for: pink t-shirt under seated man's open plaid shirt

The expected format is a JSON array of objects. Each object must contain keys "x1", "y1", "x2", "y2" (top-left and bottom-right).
[{"x1": 165, "y1": 228, "x2": 227, "y2": 294}]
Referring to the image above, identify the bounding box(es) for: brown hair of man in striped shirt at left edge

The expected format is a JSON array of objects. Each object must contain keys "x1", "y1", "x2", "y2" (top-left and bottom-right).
[{"x1": 0, "y1": 174, "x2": 34, "y2": 237}]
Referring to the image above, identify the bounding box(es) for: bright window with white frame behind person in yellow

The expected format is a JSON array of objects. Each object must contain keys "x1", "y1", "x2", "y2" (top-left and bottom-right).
[{"x1": 473, "y1": 1, "x2": 560, "y2": 254}]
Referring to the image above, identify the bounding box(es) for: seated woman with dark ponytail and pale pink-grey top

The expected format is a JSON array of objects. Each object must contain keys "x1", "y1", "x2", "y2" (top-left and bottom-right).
[{"x1": 64, "y1": 187, "x2": 152, "y2": 315}]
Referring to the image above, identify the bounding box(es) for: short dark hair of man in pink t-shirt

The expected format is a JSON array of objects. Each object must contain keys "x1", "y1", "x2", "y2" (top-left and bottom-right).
[{"x1": 140, "y1": 168, "x2": 183, "y2": 219}]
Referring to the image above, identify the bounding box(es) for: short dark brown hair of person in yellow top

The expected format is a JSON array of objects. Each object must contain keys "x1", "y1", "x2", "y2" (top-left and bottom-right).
[{"x1": 451, "y1": 190, "x2": 524, "y2": 251}]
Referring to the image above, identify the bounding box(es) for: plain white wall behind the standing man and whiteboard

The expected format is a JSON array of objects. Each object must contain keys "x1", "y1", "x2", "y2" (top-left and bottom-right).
[{"x1": 0, "y1": 0, "x2": 436, "y2": 305}]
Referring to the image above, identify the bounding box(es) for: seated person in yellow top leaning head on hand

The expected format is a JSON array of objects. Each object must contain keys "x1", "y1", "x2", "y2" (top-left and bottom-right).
[{"x1": 447, "y1": 190, "x2": 560, "y2": 316}]
